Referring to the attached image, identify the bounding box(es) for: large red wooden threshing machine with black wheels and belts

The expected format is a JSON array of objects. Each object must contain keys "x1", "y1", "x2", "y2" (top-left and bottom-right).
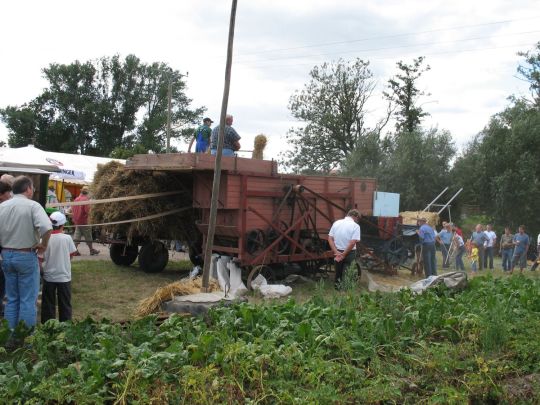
[{"x1": 107, "y1": 153, "x2": 416, "y2": 285}]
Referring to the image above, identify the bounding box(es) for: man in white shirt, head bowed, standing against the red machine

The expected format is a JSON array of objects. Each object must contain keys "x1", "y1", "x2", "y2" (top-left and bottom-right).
[{"x1": 328, "y1": 209, "x2": 360, "y2": 288}]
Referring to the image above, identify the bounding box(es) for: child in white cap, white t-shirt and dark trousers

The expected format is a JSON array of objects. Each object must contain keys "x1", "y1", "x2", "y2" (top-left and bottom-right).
[{"x1": 41, "y1": 211, "x2": 77, "y2": 323}]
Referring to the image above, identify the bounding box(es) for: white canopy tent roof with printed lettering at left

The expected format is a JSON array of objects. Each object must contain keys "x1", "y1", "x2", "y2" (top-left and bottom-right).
[{"x1": 0, "y1": 145, "x2": 126, "y2": 183}]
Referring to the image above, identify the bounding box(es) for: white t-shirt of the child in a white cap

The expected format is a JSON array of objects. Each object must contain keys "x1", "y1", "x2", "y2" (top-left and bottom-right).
[{"x1": 43, "y1": 233, "x2": 77, "y2": 283}]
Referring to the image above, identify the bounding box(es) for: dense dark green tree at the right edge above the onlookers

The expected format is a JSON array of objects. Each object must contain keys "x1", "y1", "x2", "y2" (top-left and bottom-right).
[{"x1": 452, "y1": 100, "x2": 540, "y2": 230}]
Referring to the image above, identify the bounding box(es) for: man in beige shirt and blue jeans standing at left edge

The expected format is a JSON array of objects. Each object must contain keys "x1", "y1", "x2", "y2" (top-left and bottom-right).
[{"x1": 0, "y1": 176, "x2": 52, "y2": 330}]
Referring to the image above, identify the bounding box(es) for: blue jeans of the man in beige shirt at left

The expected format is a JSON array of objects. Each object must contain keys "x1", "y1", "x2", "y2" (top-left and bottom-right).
[{"x1": 2, "y1": 250, "x2": 39, "y2": 329}]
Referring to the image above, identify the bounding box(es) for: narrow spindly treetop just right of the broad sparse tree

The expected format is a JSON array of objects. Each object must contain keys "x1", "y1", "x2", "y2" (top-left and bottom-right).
[{"x1": 384, "y1": 56, "x2": 431, "y2": 132}]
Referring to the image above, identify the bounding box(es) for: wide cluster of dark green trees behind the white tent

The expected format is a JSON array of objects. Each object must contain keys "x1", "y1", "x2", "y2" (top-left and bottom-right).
[{"x1": 0, "y1": 55, "x2": 204, "y2": 156}]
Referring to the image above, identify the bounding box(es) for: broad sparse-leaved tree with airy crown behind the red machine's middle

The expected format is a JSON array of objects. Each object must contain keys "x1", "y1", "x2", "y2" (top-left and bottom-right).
[{"x1": 284, "y1": 59, "x2": 389, "y2": 173}]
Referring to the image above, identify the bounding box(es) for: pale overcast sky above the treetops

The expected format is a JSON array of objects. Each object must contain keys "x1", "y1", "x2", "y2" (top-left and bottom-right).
[{"x1": 0, "y1": 0, "x2": 540, "y2": 158}]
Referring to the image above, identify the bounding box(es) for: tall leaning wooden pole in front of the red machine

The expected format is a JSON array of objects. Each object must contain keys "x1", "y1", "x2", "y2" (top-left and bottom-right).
[{"x1": 201, "y1": 0, "x2": 237, "y2": 292}]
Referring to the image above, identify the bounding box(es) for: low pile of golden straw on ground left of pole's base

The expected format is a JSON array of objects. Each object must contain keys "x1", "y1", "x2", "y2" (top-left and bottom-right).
[{"x1": 135, "y1": 277, "x2": 220, "y2": 318}]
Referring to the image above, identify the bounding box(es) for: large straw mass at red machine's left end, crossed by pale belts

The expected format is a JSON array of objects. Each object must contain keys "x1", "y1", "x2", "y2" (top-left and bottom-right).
[{"x1": 90, "y1": 161, "x2": 196, "y2": 241}]
